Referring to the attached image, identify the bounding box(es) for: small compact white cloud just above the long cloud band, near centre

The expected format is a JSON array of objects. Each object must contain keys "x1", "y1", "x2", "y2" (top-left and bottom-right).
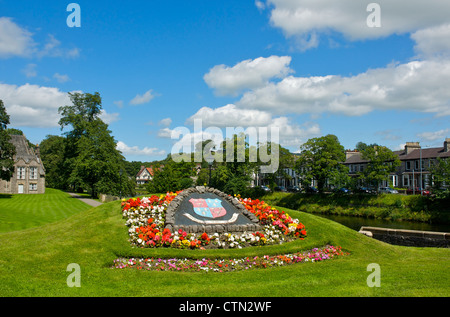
[{"x1": 203, "y1": 56, "x2": 292, "y2": 95}]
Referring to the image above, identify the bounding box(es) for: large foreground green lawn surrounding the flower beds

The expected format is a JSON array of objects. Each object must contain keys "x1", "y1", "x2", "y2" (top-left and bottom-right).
[{"x1": 0, "y1": 190, "x2": 450, "y2": 297}]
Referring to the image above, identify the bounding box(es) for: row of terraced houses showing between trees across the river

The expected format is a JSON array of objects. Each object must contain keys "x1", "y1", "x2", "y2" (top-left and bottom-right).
[{"x1": 254, "y1": 138, "x2": 450, "y2": 189}]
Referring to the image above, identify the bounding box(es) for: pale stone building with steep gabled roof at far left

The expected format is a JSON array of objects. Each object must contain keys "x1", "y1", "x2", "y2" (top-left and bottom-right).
[{"x1": 0, "y1": 135, "x2": 45, "y2": 194}]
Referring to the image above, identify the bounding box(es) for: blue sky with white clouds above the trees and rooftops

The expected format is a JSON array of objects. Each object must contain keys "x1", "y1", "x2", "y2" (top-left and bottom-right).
[{"x1": 0, "y1": 0, "x2": 450, "y2": 161}]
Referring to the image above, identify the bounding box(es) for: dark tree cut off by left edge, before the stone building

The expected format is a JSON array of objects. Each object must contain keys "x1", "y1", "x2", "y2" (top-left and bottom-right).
[{"x1": 0, "y1": 100, "x2": 16, "y2": 181}]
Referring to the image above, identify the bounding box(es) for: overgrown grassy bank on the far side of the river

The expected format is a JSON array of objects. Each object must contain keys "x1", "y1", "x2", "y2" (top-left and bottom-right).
[{"x1": 261, "y1": 193, "x2": 450, "y2": 224}]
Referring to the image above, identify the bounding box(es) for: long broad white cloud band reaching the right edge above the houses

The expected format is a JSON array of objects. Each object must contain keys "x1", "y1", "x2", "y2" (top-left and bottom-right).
[{"x1": 236, "y1": 60, "x2": 450, "y2": 116}]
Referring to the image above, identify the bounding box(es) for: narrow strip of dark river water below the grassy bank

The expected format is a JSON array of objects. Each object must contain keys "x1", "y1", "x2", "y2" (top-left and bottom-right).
[{"x1": 315, "y1": 214, "x2": 450, "y2": 232}]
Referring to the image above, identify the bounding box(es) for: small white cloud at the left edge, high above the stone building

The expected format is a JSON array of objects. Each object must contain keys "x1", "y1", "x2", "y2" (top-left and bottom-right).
[{"x1": 0, "y1": 17, "x2": 36, "y2": 58}]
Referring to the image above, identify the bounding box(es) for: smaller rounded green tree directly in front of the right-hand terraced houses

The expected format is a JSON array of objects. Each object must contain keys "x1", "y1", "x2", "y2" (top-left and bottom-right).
[{"x1": 360, "y1": 145, "x2": 400, "y2": 188}]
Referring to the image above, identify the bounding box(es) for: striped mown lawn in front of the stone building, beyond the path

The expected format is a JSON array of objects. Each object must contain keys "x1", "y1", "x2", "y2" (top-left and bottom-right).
[{"x1": 0, "y1": 188, "x2": 90, "y2": 232}]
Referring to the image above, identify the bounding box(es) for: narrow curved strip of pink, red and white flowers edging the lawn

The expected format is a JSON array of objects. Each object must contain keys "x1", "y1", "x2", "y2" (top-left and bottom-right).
[{"x1": 112, "y1": 246, "x2": 345, "y2": 272}]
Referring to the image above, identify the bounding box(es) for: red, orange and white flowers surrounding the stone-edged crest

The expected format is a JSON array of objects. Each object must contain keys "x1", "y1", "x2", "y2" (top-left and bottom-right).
[{"x1": 122, "y1": 191, "x2": 307, "y2": 249}]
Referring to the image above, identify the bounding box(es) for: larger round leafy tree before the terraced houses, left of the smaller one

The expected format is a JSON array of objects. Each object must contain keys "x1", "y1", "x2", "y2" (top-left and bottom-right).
[{"x1": 295, "y1": 134, "x2": 345, "y2": 192}]
